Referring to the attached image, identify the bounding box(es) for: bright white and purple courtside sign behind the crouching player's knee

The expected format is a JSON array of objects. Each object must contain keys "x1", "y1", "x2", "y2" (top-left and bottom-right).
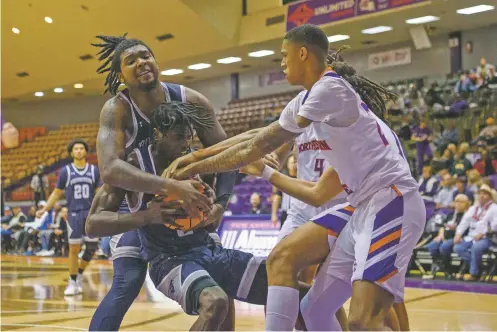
[{"x1": 218, "y1": 215, "x2": 280, "y2": 257}]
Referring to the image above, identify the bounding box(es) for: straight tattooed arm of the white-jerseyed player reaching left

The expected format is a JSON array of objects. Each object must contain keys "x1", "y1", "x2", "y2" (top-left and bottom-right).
[{"x1": 175, "y1": 122, "x2": 298, "y2": 179}]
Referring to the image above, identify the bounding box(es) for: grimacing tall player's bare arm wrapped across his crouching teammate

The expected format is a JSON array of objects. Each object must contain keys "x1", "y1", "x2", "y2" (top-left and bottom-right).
[{"x1": 97, "y1": 97, "x2": 211, "y2": 217}]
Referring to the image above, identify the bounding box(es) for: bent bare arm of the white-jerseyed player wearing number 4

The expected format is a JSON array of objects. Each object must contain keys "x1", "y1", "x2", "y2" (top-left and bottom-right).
[{"x1": 241, "y1": 161, "x2": 343, "y2": 207}]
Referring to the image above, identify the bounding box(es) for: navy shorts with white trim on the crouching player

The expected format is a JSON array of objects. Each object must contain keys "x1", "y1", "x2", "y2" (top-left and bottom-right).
[{"x1": 149, "y1": 244, "x2": 268, "y2": 315}]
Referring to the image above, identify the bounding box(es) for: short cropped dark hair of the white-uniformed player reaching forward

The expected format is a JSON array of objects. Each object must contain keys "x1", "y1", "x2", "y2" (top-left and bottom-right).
[{"x1": 284, "y1": 24, "x2": 329, "y2": 61}]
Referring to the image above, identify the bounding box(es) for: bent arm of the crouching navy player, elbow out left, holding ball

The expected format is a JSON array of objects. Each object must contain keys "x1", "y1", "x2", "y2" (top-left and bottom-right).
[{"x1": 85, "y1": 184, "x2": 179, "y2": 237}]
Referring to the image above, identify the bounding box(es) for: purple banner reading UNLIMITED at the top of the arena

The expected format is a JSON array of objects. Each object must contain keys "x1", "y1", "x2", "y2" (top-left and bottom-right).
[{"x1": 286, "y1": 0, "x2": 428, "y2": 31}]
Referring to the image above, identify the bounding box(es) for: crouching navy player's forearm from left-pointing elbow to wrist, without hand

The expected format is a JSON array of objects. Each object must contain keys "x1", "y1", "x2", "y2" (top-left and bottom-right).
[{"x1": 85, "y1": 211, "x2": 148, "y2": 237}]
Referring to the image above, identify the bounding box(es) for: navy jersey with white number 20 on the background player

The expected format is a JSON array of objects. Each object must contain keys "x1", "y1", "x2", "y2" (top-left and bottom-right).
[{"x1": 57, "y1": 163, "x2": 100, "y2": 212}]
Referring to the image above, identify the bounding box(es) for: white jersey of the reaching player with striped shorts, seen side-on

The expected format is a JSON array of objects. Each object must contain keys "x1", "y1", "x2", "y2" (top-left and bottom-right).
[{"x1": 280, "y1": 72, "x2": 417, "y2": 206}]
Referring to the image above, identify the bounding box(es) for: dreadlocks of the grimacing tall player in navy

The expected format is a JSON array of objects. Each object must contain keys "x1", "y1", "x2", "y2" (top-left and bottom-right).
[{"x1": 91, "y1": 33, "x2": 154, "y2": 96}]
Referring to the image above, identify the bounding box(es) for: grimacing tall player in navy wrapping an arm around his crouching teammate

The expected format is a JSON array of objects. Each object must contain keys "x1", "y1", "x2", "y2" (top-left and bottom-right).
[{"x1": 90, "y1": 34, "x2": 236, "y2": 330}]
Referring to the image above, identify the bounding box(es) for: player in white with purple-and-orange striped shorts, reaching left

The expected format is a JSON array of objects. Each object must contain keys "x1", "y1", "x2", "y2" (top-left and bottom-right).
[{"x1": 171, "y1": 24, "x2": 425, "y2": 331}]
